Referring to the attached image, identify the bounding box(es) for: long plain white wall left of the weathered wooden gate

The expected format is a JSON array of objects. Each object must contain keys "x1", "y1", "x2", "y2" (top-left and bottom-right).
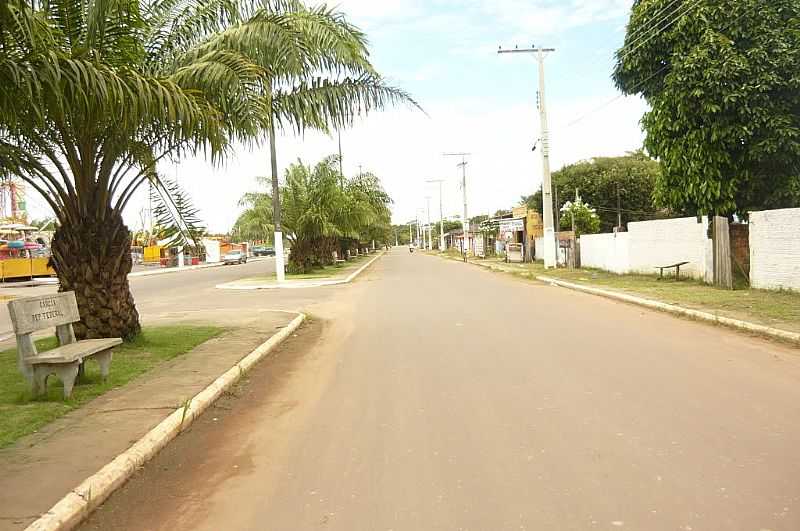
[{"x1": 581, "y1": 217, "x2": 713, "y2": 282}]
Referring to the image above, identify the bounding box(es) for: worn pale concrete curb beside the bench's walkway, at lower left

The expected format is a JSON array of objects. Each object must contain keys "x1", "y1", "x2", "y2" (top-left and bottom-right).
[{"x1": 26, "y1": 310, "x2": 306, "y2": 531}]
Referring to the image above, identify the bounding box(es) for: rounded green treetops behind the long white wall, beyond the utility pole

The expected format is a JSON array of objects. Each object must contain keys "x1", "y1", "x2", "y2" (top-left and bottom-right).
[{"x1": 521, "y1": 151, "x2": 664, "y2": 232}]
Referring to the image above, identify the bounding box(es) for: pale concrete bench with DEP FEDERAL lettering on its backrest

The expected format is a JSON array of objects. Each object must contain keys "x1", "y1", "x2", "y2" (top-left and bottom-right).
[{"x1": 8, "y1": 291, "x2": 122, "y2": 398}]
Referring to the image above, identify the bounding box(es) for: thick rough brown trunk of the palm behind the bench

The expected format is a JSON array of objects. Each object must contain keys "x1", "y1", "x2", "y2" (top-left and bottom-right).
[{"x1": 52, "y1": 209, "x2": 141, "y2": 340}]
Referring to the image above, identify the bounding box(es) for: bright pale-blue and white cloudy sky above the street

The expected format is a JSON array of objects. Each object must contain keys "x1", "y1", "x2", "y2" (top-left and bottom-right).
[{"x1": 21, "y1": 0, "x2": 646, "y2": 233}]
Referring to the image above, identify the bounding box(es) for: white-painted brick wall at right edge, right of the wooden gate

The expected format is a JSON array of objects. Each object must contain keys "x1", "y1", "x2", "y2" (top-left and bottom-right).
[{"x1": 750, "y1": 208, "x2": 800, "y2": 290}]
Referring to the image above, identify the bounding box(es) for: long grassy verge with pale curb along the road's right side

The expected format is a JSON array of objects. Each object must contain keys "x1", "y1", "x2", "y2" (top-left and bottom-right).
[{"x1": 439, "y1": 255, "x2": 800, "y2": 343}]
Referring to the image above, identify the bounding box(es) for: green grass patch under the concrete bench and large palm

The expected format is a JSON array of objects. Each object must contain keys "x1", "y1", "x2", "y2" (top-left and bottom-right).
[{"x1": 0, "y1": 326, "x2": 224, "y2": 448}]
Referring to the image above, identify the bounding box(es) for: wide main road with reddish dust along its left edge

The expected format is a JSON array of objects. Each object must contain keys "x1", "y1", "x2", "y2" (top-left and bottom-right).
[{"x1": 83, "y1": 250, "x2": 800, "y2": 531}]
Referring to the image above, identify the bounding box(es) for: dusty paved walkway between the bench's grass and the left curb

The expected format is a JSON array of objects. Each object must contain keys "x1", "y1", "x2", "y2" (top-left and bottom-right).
[{"x1": 0, "y1": 310, "x2": 295, "y2": 531}]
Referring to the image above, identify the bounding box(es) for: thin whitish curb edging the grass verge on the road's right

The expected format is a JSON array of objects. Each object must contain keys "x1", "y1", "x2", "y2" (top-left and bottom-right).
[{"x1": 536, "y1": 276, "x2": 800, "y2": 344}]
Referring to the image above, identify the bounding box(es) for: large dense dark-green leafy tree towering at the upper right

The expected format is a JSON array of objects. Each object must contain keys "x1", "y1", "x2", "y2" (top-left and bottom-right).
[{"x1": 614, "y1": 0, "x2": 800, "y2": 215}]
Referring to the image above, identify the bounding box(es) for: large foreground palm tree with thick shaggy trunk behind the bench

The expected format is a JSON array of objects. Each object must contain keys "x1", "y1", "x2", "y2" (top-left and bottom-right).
[{"x1": 0, "y1": 0, "x2": 418, "y2": 338}]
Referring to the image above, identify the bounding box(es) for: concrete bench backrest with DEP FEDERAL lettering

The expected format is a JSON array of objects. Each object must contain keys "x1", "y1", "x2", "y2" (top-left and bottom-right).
[{"x1": 8, "y1": 291, "x2": 81, "y2": 335}]
